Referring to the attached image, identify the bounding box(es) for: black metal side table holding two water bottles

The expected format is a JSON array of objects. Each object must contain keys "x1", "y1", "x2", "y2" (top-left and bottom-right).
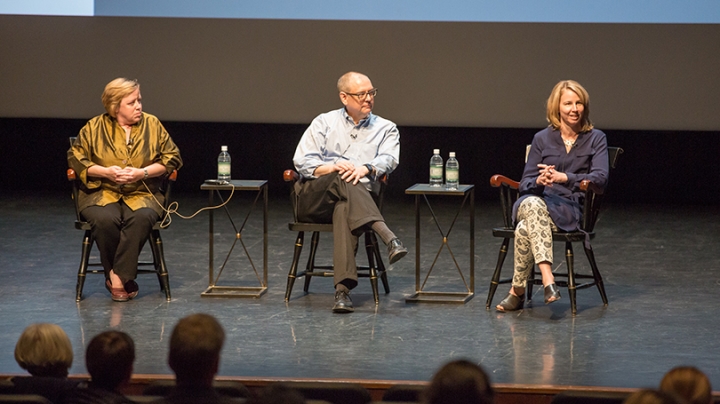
[{"x1": 405, "y1": 184, "x2": 475, "y2": 303}]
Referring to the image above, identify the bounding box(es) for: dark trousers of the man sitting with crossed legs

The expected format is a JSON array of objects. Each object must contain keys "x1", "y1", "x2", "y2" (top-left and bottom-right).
[{"x1": 295, "y1": 172, "x2": 385, "y2": 289}]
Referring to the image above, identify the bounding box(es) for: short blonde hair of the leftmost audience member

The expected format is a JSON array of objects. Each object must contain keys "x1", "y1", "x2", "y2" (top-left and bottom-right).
[{"x1": 15, "y1": 323, "x2": 73, "y2": 377}]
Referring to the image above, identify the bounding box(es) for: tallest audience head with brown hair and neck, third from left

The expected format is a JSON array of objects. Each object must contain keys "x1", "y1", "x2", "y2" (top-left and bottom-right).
[{"x1": 153, "y1": 313, "x2": 236, "y2": 404}]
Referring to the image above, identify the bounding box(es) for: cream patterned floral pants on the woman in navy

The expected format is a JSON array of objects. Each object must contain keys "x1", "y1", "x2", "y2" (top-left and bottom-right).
[{"x1": 512, "y1": 196, "x2": 557, "y2": 288}]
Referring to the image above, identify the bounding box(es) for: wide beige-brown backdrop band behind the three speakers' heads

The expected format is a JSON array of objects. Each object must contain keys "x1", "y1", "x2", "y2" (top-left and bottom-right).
[{"x1": 0, "y1": 15, "x2": 720, "y2": 130}]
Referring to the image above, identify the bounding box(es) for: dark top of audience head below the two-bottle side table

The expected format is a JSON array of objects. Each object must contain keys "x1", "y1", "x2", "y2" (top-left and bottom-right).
[{"x1": 422, "y1": 359, "x2": 495, "y2": 404}]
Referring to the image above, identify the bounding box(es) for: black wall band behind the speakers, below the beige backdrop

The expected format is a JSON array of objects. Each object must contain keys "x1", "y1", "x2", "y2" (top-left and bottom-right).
[{"x1": 0, "y1": 118, "x2": 720, "y2": 204}]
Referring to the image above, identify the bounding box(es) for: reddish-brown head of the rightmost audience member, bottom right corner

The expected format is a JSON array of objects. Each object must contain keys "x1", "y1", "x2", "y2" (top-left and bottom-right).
[{"x1": 660, "y1": 366, "x2": 713, "y2": 404}]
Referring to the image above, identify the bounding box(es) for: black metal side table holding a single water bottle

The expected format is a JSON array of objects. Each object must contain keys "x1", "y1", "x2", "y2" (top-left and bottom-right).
[{"x1": 200, "y1": 180, "x2": 268, "y2": 298}]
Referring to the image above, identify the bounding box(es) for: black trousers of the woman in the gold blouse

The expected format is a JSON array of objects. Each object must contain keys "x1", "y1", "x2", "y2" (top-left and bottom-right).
[{"x1": 80, "y1": 200, "x2": 158, "y2": 281}]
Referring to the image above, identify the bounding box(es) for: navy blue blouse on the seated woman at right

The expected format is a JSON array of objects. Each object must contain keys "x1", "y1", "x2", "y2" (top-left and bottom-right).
[{"x1": 513, "y1": 127, "x2": 609, "y2": 231}]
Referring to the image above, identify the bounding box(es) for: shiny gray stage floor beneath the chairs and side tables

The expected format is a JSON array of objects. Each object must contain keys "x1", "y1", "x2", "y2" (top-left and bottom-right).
[{"x1": 0, "y1": 191, "x2": 720, "y2": 387}]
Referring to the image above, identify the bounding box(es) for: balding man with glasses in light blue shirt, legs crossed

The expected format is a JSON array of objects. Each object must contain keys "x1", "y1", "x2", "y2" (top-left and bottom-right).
[{"x1": 293, "y1": 72, "x2": 407, "y2": 313}]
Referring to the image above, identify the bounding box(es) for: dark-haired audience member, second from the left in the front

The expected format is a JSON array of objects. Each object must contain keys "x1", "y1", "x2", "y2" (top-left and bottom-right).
[{"x1": 60, "y1": 331, "x2": 135, "y2": 404}]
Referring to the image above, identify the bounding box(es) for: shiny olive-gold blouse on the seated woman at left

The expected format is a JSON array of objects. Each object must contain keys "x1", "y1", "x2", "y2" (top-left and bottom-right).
[{"x1": 68, "y1": 112, "x2": 182, "y2": 215}]
